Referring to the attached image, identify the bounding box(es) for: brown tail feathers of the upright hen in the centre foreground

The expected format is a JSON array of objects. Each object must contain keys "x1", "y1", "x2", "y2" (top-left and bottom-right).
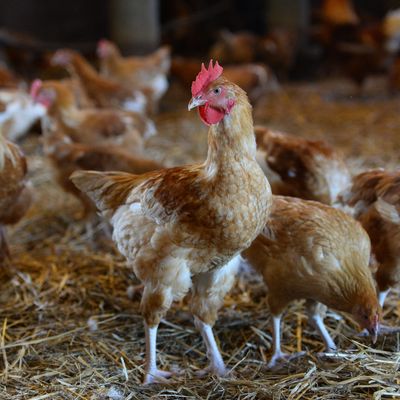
[{"x1": 70, "y1": 171, "x2": 145, "y2": 217}]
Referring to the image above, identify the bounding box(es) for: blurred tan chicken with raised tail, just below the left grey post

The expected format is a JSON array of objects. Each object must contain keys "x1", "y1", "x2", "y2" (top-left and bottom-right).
[{"x1": 97, "y1": 39, "x2": 171, "y2": 113}]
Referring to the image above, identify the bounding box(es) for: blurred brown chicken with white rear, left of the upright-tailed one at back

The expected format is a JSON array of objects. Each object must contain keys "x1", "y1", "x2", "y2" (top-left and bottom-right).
[{"x1": 51, "y1": 49, "x2": 146, "y2": 113}]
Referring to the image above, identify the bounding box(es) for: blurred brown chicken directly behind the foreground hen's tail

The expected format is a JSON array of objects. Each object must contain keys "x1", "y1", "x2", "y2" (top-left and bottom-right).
[{"x1": 43, "y1": 127, "x2": 163, "y2": 219}]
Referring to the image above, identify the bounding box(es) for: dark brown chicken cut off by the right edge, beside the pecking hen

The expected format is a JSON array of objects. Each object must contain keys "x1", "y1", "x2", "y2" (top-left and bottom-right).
[{"x1": 338, "y1": 170, "x2": 400, "y2": 307}]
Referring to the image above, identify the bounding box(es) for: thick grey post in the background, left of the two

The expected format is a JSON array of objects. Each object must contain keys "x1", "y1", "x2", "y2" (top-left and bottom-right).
[{"x1": 110, "y1": 0, "x2": 160, "y2": 53}]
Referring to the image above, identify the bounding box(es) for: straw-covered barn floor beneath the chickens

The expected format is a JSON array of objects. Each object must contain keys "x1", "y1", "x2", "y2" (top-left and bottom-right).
[{"x1": 0, "y1": 79, "x2": 400, "y2": 400}]
